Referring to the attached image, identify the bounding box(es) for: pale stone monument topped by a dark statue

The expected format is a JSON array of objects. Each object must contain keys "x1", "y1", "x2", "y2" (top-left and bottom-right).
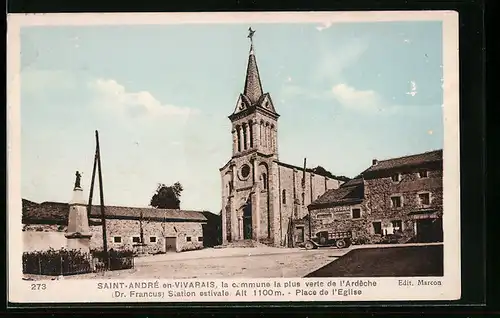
[{"x1": 65, "y1": 171, "x2": 92, "y2": 253}]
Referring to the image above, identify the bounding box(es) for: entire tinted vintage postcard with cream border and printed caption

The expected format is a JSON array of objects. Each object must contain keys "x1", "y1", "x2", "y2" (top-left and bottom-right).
[{"x1": 7, "y1": 11, "x2": 461, "y2": 303}]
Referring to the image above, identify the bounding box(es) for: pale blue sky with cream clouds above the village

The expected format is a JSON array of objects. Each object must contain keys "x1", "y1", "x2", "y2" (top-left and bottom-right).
[{"x1": 20, "y1": 21, "x2": 443, "y2": 213}]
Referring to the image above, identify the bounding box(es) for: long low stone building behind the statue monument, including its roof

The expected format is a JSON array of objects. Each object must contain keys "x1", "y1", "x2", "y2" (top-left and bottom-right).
[{"x1": 22, "y1": 199, "x2": 207, "y2": 254}]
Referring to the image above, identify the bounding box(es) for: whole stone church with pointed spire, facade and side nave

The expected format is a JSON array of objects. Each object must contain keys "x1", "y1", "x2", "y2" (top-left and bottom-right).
[{"x1": 220, "y1": 29, "x2": 342, "y2": 246}]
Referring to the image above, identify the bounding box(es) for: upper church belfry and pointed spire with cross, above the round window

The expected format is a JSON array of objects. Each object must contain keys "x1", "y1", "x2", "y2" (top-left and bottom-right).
[{"x1": 229, "y1": 28, "x2": 279, "y2": 159}]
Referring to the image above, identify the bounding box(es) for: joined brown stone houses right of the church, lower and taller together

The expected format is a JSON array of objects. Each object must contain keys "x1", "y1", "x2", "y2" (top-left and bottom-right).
[{"x1": 302, "y1": 150, "x2": 443, "y2": 245}]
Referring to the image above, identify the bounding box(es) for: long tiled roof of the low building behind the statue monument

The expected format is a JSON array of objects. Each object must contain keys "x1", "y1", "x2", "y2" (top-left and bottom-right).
[{"x1": 22, "y1": 199, "x2": 207, "y2": 224}]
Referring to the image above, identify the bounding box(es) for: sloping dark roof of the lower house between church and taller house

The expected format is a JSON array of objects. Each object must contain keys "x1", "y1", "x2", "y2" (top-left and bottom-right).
[{"x1": 309, "y1": 178, "x2": 364, "y2": 209}]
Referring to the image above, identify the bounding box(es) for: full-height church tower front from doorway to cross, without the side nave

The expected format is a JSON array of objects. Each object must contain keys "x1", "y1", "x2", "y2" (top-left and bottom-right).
[{"x1": 220, "y1": 28, "x2": 279, "y2": 243}]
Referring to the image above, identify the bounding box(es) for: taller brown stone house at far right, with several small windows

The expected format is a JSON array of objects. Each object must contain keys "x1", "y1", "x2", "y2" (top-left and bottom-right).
[{"x1": 362, "y1": 150, "x2": 443, "y2": 242}]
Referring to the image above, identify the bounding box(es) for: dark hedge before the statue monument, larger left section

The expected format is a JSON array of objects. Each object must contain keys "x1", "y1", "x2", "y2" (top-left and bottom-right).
[{"x1": 23, "y1": 248, "x2": 92, "y2": 275}]
